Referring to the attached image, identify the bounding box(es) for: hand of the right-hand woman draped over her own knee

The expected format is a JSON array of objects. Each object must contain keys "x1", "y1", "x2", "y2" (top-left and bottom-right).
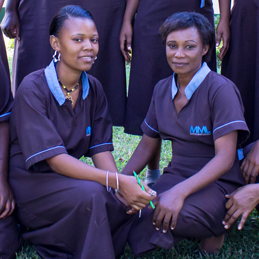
[{"x1": 153, "y1": 186, "x2": 186, "y2": 233}]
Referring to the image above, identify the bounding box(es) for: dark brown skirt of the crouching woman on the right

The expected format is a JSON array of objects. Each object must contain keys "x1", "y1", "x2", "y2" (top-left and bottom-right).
[{"x1": 128, "y1": 157, "x2": 244, "y2": 256}]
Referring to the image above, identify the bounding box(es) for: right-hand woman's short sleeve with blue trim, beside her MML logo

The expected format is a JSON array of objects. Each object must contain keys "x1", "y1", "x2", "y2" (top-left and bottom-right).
[{"x1": 211, "y1": 81, "x2": 252, "y2": 144}]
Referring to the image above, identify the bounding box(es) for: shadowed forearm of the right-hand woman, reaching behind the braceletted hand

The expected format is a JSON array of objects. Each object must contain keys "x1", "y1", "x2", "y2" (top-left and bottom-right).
[{"x1": 122, "y1": 134, "x2": 161, "y2": 175}]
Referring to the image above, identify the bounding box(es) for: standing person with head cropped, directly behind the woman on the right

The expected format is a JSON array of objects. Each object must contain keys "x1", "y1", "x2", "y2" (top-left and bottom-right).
[{"x1": 120, "y1": 0, "x2": 230, "y2": 188}]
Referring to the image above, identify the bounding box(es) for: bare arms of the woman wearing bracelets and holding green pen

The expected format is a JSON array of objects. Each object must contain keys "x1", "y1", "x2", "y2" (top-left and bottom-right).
[{"x1": 46, "y1": 151, "x2": 155, "y2": 210}]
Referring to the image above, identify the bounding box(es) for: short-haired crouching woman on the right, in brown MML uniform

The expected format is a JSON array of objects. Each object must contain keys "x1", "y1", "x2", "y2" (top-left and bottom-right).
[{"x1": 123, "y1": 12, "x2": 249, "y2": 255}]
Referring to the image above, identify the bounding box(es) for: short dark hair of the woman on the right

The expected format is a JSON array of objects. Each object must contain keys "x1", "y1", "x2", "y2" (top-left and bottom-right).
[{"x1": 159, "y1": 12, "x2": 215, "y2": 62}]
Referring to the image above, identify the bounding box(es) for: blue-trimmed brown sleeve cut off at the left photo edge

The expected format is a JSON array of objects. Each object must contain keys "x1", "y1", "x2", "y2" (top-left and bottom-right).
[{"x1": 0, "y1": 56, "x2": 13, "y2": 122}]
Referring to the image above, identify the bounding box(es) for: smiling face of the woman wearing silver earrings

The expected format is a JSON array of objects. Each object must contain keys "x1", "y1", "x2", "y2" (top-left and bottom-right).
[{"x1": 50, "y1": 18, "x2": 99, "y2": 71}]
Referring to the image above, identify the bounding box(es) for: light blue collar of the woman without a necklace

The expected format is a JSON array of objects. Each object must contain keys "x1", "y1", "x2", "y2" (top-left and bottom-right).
[{"x1": 172, "y1": 62, "x2": 211, "y2": 100}]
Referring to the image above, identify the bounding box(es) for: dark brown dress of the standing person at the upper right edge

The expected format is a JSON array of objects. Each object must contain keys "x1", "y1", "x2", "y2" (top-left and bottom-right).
[{"x1": 221, "y1": 0, "x2": 259, "y2": 144}]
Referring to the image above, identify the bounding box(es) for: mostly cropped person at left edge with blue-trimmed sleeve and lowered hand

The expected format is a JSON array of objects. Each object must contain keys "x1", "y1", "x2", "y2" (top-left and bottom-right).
[{"x1": 0, "y1": 0, "x2": 22, "y2": 259}]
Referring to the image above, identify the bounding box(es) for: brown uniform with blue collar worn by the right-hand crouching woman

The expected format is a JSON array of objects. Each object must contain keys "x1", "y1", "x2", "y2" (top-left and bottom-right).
[{"x1": 129, "y1": 63, "x2": 249, "y2": 255}]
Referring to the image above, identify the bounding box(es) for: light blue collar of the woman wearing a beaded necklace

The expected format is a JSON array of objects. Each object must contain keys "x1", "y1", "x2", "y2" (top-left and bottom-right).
[{"x1": 44, "y1": 60, "x2": 90, "y2": 106}]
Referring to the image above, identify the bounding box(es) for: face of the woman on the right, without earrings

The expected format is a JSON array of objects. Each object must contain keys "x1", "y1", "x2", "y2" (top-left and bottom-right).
[{"x1": 166, "y1": 27, "x2": 209, "y2": 76}]
